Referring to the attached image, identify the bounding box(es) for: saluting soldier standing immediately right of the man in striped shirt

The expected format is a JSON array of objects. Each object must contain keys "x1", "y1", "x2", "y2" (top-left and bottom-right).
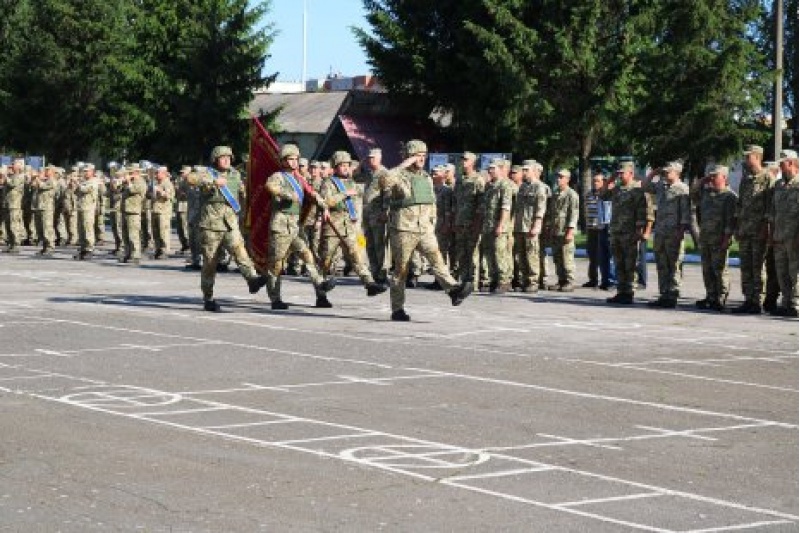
[{"x1": 600, "y1": 161, "x2": 653, "y2": 305}]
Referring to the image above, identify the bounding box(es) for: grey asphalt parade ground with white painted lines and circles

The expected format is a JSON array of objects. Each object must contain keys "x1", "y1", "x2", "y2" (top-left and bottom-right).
[{"x1": 0, "y1": 242, "x2": 798, "y2": 533}]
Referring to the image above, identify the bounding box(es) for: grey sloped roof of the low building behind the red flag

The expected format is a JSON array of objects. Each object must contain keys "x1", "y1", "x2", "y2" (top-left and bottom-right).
[{"x1": 250, "y1": 92, "x2": 348, "y2": 135}]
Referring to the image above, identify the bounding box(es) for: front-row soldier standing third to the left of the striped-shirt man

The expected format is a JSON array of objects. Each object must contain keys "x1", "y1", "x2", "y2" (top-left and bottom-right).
[{"x1": 481, "y1": 159, "x2": 514, "y2": 294}]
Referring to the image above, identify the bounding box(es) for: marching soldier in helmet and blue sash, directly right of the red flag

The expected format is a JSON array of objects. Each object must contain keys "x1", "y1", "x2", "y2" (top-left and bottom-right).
[{"x1": 266, "y1": 144, "x2": 336, "y2": 310}]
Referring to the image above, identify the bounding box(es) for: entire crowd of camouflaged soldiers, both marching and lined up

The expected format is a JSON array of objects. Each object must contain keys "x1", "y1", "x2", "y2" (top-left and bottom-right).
[{"x1": 0, "y1": 140, "x2": 798, "y2": 321}]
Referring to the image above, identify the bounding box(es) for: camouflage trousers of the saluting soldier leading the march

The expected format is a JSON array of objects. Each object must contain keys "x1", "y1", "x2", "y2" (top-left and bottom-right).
[{"x1": 389, "y1": 230, "x2": 458, "y2": 312}]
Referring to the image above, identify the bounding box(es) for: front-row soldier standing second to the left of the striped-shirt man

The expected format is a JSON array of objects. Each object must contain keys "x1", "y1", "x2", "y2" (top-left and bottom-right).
[{"x1": 513, "y1": 159, "x2": 547, "y2": 293}]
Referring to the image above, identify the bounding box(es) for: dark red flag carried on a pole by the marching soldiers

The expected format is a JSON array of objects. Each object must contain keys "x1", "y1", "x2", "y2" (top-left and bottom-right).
[{"x1": 245, "y1": 117, "x2": 281, "y2": 270}]
